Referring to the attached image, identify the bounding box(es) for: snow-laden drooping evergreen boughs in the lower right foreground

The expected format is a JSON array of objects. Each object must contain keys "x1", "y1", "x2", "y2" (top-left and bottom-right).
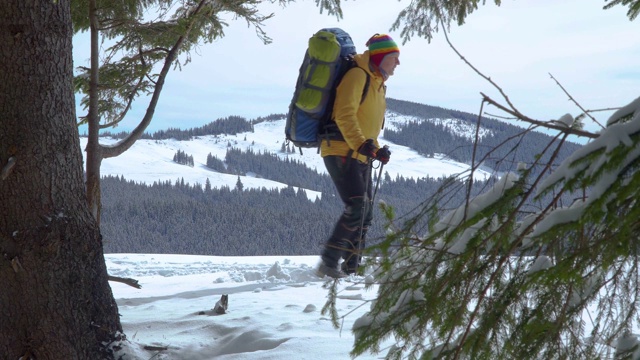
[{"x1": 325, "y1": 98, "x2": 640, "y2": 359}]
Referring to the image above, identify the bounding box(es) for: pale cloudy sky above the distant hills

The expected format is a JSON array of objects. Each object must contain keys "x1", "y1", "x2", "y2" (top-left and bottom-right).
[{"x1": 74, "y1": 0, "x2": 640, "y2": 132}]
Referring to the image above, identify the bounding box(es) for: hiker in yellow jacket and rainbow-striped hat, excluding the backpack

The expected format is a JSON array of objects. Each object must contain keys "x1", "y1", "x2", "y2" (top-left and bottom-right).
[{"x1": 317, "y1": 34, "x2": 400, "y2": 278}]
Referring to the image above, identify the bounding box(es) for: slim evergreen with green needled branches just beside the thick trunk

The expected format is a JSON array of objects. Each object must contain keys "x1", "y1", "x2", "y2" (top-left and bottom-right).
[{"x1": 70, "y1": 0, "x2": 286, "y2": 222}]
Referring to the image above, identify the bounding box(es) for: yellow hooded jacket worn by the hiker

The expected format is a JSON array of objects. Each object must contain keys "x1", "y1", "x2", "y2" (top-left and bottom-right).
[{"x1": 320, "y1": 50, "x2": 387, "y2": 162}]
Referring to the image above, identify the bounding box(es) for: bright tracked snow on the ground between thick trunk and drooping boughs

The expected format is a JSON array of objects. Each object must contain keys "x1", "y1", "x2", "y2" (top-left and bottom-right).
[{"x1": 105, "y1": 254, "x2": 390, "y2": 360}]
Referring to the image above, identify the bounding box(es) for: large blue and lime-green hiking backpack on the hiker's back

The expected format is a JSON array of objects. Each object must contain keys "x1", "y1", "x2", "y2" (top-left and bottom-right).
[{"x1": 285, "y1": 28, "x2": 370, "y2": 151}]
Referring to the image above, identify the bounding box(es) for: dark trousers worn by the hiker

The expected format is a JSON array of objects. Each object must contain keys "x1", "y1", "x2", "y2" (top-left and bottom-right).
[{"x1": 322, "y1": 156, "x2": 373, "y2": 269}]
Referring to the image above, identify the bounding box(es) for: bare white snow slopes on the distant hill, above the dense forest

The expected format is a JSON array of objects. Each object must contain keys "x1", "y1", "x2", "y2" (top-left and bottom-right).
[{"x1": 80, "y1": 111, "x2": 489, "y2": 199}]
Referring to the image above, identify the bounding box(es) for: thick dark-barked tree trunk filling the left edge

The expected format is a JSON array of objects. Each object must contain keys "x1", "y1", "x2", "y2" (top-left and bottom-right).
[{"x1": 0, "y1": 0, "x2": 121, "y2": 360}]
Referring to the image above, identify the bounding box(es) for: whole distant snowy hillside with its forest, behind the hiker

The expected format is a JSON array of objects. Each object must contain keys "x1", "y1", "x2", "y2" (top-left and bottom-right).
[{"x1": 92, "y1": 100, "x2": 576, "y2": 256}]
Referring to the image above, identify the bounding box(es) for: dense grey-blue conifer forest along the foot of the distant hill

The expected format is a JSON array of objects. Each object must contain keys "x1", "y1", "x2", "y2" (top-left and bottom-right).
[{"x1": 101, "y1": 170, "x2": 484, "y2": 256}]
